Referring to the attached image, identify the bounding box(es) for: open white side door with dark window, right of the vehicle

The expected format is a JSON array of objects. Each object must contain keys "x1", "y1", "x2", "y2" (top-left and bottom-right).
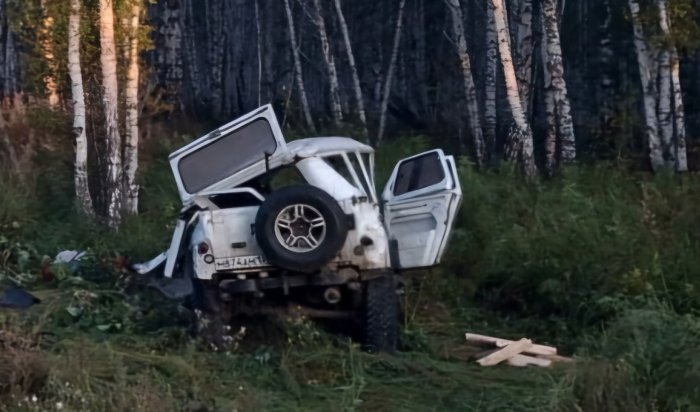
[{"x1": 382, "y1": 149, "x2": 462, "y2": 269}]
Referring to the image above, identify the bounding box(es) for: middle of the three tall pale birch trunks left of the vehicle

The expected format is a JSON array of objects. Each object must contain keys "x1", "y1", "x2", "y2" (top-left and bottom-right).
[{"x1": 100, "y1": 0, "x2": 122, "y2": 228}]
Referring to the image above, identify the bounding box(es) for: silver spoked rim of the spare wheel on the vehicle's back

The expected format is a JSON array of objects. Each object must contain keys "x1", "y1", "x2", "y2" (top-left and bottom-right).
[{"x1": 275, "y1": 203, "x2": 326, "y2": 253}]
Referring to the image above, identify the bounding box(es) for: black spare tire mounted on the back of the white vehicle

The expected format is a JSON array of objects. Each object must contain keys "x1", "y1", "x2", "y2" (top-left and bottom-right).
[{"x1": 255, "y1": 186, "x2": 349, "y2": 273}]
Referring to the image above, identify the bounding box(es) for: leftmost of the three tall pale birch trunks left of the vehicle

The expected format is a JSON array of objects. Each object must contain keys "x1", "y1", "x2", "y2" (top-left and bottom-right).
[{"x1": 68, "y1": 0, "x2": 95, "y2": 217}]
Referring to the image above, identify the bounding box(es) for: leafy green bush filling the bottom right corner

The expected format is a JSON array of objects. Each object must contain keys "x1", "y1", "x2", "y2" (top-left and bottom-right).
[{"x1": 574, "y1": 303, "x2": 700, "y2": 411}]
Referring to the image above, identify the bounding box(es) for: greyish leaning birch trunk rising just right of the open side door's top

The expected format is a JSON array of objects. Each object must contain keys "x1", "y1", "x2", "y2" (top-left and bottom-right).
[{"x1": 446, "y1": 0, "x2": 485, "y2": 167}]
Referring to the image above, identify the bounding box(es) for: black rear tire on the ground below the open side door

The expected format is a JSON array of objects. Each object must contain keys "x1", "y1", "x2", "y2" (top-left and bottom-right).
[{"x1": 363, "y1": 275, "x2": 399, "y2": 353}]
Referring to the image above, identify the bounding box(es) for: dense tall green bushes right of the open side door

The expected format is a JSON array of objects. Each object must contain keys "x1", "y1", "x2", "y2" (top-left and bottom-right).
[{"x1": 450, "y1": 164, "x2": 700, "y2": 329}]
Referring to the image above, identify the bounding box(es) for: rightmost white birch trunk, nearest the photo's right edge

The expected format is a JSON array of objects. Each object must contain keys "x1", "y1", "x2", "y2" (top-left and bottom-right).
[{"x1": 657, "y1": 0, "x2": 688, "y2": 172}]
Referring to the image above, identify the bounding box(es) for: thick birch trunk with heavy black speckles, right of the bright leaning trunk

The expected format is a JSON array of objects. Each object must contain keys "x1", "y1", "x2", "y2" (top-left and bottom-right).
[{"x1": 542, "y1": 0, "x2": 576, "y2": 164}]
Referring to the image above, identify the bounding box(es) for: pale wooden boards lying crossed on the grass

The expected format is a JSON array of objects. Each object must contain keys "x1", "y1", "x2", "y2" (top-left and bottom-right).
[{"x1": 465, "y1": 333, "x2": 573, "y2": 367}]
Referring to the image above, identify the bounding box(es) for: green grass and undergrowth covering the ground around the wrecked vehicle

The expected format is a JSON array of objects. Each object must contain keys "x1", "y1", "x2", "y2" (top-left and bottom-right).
[{"x1": 0, "y1": 138, "x2": 700, "y2": 411}]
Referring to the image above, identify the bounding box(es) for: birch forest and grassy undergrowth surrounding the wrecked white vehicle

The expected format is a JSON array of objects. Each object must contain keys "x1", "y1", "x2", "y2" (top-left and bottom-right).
[{"x1": 0, "y1": 0, "x2": 700, "y2": 411}]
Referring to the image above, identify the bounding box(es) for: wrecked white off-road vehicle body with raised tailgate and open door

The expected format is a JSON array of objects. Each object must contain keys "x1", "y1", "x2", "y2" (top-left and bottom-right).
[{"x1": 135, "y1": 105, "x2": 462, "y2": 292}]
